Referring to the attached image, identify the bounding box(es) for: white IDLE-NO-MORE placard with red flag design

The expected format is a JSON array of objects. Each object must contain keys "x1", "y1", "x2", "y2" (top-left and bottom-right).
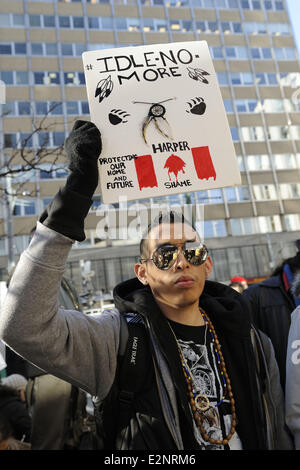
[{"x1": 83, "y1": 41, "x2": 241, "y2": 203}]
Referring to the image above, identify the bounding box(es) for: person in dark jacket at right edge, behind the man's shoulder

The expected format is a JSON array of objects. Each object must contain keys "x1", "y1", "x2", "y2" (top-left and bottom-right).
[{"x1": 242, "y1": 251, "x2": 300, "y2": 390}]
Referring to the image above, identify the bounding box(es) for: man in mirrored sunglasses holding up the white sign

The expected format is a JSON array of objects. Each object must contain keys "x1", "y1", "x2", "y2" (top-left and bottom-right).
[{"x1": 0, "y1": 121, "x2": 291, "y2": 452}]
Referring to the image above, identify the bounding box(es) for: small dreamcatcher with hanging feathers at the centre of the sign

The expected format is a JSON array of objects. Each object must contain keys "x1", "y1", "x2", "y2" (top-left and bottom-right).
[{"x1": 133, "y1": 98, "x2": 176, "y2": 144}]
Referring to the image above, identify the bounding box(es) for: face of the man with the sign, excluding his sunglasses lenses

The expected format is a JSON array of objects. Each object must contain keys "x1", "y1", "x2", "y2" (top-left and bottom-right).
[{"x1": 135, "y1": 223, "x2": 212, "y2": 308}]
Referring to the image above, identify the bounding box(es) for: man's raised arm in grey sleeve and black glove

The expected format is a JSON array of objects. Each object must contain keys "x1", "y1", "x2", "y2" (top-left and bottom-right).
[{"x1": 0, "y1": 121, "x2": 120, "y2": 396}]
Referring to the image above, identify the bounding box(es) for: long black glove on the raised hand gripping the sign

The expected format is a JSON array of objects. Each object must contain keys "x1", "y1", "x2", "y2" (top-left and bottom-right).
[{"x1": 39, "y1": 121, "x2": 102, "y2": 241}]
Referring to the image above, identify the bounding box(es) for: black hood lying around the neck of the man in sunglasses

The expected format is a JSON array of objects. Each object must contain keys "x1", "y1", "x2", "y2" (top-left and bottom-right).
[{"x1": 113, "y1": 278, "x2": 250, "y2": 336}]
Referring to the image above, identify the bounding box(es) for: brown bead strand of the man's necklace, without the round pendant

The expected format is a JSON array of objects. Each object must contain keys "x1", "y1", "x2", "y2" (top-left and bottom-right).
[{"x1": 173, "y1": 309, "x2": 237, "y2": 445}]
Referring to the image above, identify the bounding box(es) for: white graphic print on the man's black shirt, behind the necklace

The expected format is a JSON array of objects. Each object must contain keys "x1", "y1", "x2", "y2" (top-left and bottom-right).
[{"x1": 178, "y1": 339, "x2": 237, "y2": 450}]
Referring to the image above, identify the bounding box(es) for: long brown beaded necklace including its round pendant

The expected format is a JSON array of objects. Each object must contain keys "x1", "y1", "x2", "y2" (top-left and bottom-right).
[{"x1": 169, "y1": 308, "x2": 236, "y2": 445}]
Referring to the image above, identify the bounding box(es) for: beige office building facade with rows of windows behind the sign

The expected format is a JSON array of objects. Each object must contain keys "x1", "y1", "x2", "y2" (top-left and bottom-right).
[{"x1": 0, "y1": 0, "x2": 300, "y2": 292}]
